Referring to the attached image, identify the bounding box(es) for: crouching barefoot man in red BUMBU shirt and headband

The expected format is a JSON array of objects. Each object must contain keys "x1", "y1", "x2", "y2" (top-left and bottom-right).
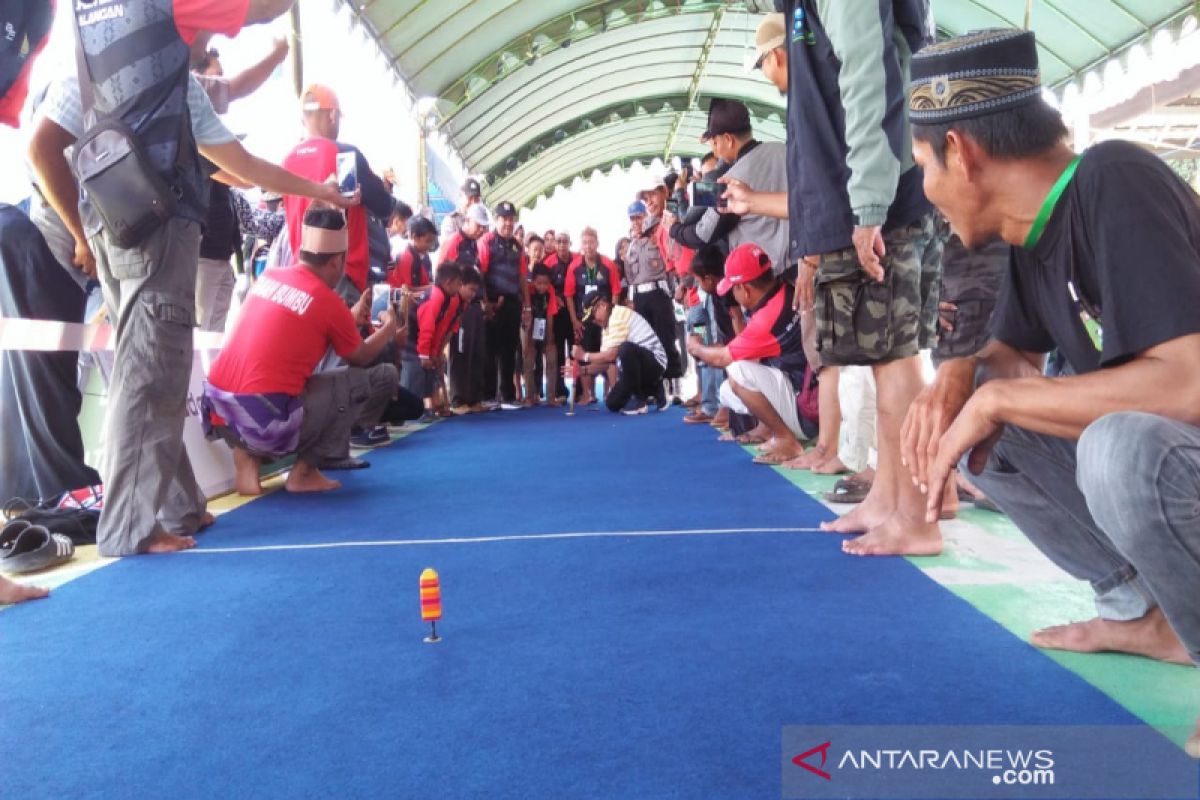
[{"x1": 203, "y1": 209, "x2": 398, "y2": 494}]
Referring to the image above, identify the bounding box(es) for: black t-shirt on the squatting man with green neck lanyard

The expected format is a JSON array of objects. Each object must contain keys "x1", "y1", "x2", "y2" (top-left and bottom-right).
[{"x1": 994, "y1": 142, "x2": 1200, "y2": 374}]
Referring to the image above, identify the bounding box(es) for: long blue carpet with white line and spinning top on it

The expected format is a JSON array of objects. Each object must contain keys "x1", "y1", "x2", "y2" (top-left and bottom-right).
[{"x1": 0, "y1": 411, "x2": 1185, "y2": 799}]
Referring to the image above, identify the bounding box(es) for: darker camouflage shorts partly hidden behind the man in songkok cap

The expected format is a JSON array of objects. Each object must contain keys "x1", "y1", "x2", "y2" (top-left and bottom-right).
[{"x1": 934, "y1": 236, "x2": 1010, "y2": 363}]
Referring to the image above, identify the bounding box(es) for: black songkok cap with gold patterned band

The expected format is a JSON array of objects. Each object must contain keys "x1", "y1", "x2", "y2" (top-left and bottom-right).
[{"x1": 908, "y1": 28, "x2": 1042, "y2": 125}]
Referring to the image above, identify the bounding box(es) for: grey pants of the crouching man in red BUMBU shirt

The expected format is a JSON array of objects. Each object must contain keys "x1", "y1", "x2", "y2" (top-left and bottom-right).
[{"x1": 296, "y1": 363, "x2": 398, "y2": 467}]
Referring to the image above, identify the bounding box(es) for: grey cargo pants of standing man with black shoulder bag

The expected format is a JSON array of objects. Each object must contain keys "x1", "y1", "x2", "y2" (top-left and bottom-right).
[{"x1": 91, "y1": 217, "x2": 205, "y2": 555}]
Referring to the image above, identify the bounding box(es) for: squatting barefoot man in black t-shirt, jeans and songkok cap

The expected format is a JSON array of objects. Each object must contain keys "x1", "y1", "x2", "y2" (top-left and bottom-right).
[{"x1": 901, "y1": 30, "x2": 1200, "y2": 756}]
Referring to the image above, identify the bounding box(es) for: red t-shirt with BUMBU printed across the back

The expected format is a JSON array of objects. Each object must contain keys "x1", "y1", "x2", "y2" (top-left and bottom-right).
[{"x1": 209, "y1": 266, "x2": 362, "y2": 397}]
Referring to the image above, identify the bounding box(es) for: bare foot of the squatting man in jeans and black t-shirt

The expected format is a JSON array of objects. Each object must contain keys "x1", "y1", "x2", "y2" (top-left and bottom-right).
[{"x1": 1030, "y1": 608, "x2": 1192, "y2": 666}]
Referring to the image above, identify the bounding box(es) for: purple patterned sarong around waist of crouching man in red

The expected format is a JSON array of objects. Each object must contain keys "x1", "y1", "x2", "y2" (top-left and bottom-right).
[{"x1": 200, "y1": 383, "x2": 304, "y2": 457}]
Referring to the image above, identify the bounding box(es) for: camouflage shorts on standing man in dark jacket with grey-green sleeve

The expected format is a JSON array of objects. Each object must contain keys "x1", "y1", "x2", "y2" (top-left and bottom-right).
[{"x1": 815, "y1": 217, "x2": 941, "y2": 366}]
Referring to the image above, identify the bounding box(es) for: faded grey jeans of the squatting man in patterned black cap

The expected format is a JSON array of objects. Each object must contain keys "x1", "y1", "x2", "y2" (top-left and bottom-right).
[{"x1": 971, "y1": 411, "x2": 1200, "y2": 662}]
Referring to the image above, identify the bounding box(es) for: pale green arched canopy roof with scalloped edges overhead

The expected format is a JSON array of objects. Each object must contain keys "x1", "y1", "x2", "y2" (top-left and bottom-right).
[{"x1": 343, "y1": 0, "x2": 1194, "y2": 205}]
